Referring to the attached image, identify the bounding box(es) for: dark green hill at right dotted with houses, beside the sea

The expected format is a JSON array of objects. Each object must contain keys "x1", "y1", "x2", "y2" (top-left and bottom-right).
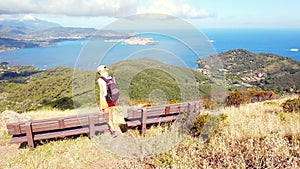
[{"x1": 198, "y1": 49, "x2": 300, "y2": 93}]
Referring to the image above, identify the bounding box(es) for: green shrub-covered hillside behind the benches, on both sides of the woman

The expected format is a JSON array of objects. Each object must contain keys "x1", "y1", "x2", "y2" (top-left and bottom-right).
[{"x1": 0, "y1": 58, "x2": 211, "y2": 112}]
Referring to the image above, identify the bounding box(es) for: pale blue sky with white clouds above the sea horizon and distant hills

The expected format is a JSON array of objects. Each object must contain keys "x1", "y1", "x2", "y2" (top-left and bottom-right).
[{"x1": 0, "y1": 0, "x2": 300, "y2": 29}]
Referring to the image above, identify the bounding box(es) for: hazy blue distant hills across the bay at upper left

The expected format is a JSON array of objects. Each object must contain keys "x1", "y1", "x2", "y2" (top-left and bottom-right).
[{"x1": 0, "y1": 19, "x2": 134, "y2": 52}]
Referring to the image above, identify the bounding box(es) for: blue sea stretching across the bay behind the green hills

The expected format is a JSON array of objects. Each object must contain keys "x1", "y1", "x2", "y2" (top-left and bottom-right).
[{"x1": 0, "y1": 29, "x2": 300, "y2": 70}]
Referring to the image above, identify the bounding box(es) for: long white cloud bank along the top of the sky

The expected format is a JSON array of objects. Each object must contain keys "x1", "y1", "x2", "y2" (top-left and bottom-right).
[{"x1": 0, "y1": 0, "x2": 210, "y2": 18}]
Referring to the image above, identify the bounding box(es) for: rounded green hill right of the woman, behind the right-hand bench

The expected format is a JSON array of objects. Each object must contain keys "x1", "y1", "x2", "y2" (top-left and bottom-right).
[{"x1": 110, "y1": 58, "x2": 211, "y2": 101}]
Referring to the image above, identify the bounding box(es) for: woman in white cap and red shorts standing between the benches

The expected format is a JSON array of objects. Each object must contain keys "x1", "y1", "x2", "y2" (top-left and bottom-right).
[{"x1": 97, "y1": 65, "x2": 117, "y2": 137}]
